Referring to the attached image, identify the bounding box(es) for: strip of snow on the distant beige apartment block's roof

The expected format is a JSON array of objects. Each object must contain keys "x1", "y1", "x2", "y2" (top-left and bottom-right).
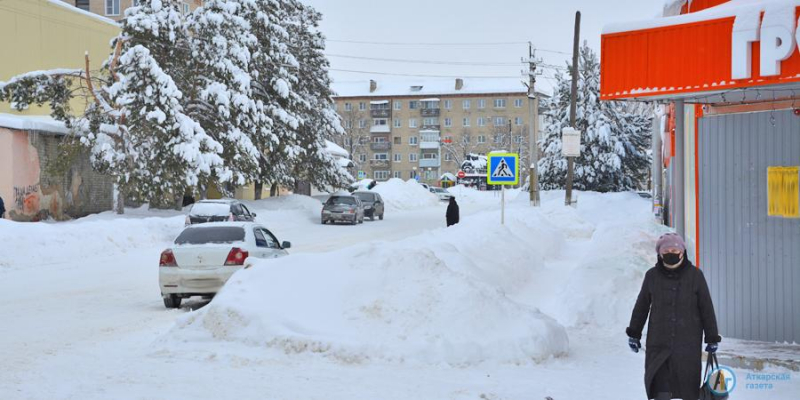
[{"x1": 333, "y1": 78, "x2": 547, "y2": 101}]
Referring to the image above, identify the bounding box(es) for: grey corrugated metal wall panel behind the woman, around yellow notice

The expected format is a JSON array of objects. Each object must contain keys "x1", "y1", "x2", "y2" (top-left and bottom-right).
[{"x1": 698, "y1": 110, "x2": 800, "y2": 343}]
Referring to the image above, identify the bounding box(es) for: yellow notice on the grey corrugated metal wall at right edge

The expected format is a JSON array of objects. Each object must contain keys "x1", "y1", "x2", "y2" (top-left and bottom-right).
[{"x1": 767, "y1": 167, "x2": 800, "y2": 218}]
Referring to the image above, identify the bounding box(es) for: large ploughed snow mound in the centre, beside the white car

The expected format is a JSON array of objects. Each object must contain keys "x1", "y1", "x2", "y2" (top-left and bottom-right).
[{"x1": 163, "y1": 203, "x2": 568, "y2": 366}]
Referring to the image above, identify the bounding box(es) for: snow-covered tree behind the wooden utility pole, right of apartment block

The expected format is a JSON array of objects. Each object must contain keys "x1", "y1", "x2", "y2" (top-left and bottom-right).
[{"x1": 539, "y1": 45, "x2": 651, "y2": 192}]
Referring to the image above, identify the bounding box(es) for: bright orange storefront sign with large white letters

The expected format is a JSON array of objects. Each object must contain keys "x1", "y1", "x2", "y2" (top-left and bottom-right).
[{"x1": 600, "y1": 0, "x2": 800, "y2": 100}]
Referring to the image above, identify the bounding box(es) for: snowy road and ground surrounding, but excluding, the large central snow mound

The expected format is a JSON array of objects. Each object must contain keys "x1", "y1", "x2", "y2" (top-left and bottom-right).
[{"x1": 0, "y1": 188, "x2": 800, "y2": 400}]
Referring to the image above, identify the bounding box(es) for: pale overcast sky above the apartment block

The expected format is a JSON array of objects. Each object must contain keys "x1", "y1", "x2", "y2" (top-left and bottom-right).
[{"x1": 304, "y1": 0, "x2": 664, "y2": 89}]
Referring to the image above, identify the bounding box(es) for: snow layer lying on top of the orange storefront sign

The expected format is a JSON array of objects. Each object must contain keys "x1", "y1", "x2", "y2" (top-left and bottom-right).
[{"x1": 603, "y1": 0, "x2": 800, "y2": 35}]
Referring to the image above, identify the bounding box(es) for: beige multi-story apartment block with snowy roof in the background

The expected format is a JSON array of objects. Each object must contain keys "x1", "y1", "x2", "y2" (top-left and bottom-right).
[{"x1": 334, "y1": 79, "x2": 542, "y2": 183}]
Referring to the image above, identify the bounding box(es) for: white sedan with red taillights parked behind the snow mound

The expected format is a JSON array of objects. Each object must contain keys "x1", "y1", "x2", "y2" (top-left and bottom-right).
[{"x1": 158, "y1": 222, "x2": 292, "y2": 308}]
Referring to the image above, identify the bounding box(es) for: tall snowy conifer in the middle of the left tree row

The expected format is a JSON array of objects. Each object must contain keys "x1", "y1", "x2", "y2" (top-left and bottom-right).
[{"x1": 185, "y1": 0, "x2": 260, "y2": 195}]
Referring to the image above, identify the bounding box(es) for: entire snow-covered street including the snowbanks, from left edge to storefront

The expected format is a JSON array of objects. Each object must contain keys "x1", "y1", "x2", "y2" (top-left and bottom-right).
[{"x1": 0, "y1": 186, "x2": 800, "y2": 400}]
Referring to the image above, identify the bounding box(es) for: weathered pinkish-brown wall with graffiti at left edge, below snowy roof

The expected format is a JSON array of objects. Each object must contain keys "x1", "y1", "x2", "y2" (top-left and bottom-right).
[{"x1": 0, "y1": 128, "x2": 113, "y2": 221}]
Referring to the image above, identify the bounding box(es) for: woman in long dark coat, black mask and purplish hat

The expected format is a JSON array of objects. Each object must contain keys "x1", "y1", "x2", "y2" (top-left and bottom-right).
[{"x1": 625, "y1": 233, "x2": 722, "y2": 400}]
